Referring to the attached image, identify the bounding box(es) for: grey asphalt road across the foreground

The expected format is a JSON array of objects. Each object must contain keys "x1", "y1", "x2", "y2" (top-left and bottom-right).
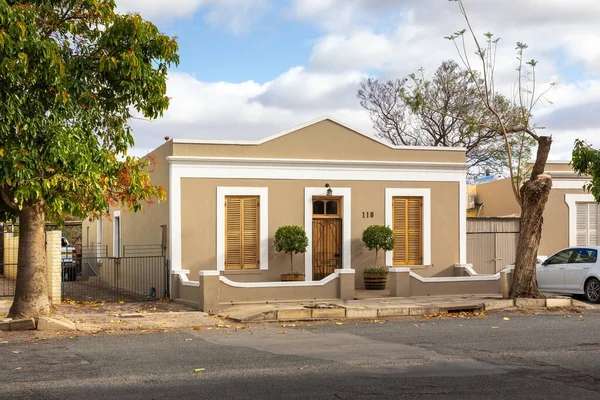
[{"x1": 0, "y1": 311, "x2": 600, "y2": 400}]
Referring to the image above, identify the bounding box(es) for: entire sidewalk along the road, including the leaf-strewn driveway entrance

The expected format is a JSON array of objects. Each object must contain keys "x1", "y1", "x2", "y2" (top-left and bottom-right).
[{"x1": 0, "y1": 295, "x2": 580, "y2": 333}]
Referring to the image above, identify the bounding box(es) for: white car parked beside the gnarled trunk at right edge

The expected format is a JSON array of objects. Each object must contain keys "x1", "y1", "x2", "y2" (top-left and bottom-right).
[{"x1": 536, "y1": 246, "x2": 600, "y2": 303}]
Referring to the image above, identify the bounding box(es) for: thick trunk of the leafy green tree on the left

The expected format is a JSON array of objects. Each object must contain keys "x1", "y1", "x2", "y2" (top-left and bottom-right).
[{"x1": 8, "y1": 203, "x2": 50, "y2": 319}]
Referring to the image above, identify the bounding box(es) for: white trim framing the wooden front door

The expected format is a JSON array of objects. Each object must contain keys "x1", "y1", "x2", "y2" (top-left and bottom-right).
[{"x1": 304, "y1": 187, "x2": 352, "y2": 281}]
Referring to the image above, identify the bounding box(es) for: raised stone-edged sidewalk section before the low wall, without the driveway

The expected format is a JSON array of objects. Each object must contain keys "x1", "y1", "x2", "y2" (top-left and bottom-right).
[{"x1": 219, "y1": 295, "x2": 580, "y2": 322}]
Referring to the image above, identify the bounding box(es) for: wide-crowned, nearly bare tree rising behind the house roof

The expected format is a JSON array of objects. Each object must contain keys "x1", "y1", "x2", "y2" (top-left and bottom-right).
[{"x1": 357, "y1": 60, "x2": 533, "y2": 180}]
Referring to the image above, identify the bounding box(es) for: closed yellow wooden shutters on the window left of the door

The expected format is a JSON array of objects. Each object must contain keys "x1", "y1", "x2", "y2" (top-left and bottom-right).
[{"x1": 225, "y1": 196, "x2": 259, "y2": 270}]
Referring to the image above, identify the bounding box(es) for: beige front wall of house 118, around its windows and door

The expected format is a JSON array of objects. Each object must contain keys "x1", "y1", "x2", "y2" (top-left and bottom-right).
[{"x1": 181, "y1": 178, "x2": 459, "y2": 288}]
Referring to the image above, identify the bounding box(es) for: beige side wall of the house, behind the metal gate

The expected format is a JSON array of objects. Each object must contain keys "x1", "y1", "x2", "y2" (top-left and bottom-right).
[{"x1": 82, "y1": 141, "x2": 173, "y2": 257}]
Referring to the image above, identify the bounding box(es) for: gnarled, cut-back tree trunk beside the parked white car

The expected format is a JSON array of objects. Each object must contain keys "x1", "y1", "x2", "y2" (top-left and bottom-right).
[{"x1": 509, "y1": 136, "x2": 552, "y2": 299}]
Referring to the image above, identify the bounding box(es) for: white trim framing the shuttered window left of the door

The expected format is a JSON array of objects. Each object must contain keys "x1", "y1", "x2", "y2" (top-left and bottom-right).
[{"x1": 217, "y1": 186, "x2": 269, "y2": 271}]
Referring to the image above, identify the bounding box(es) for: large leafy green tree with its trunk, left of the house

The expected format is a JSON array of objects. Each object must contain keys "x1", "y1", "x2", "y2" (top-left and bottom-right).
[{"x1": 0, "y1": 0, "x2": 179, "y2": 318}]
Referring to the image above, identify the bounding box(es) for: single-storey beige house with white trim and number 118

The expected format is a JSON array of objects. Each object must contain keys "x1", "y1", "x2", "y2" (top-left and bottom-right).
[{"x1": 83, "y1": 118, "x2": 488, "y2": 306}]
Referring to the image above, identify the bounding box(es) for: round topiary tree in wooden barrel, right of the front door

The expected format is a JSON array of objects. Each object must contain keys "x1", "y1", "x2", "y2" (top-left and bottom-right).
[{"x1": 362, "y1": 225, "x2": 394, "y2": 290}]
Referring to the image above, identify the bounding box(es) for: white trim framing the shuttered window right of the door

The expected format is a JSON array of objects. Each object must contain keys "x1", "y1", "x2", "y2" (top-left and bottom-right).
[{"x1": 385, "y1": 188, "x2": 432, "y2": 267}]
